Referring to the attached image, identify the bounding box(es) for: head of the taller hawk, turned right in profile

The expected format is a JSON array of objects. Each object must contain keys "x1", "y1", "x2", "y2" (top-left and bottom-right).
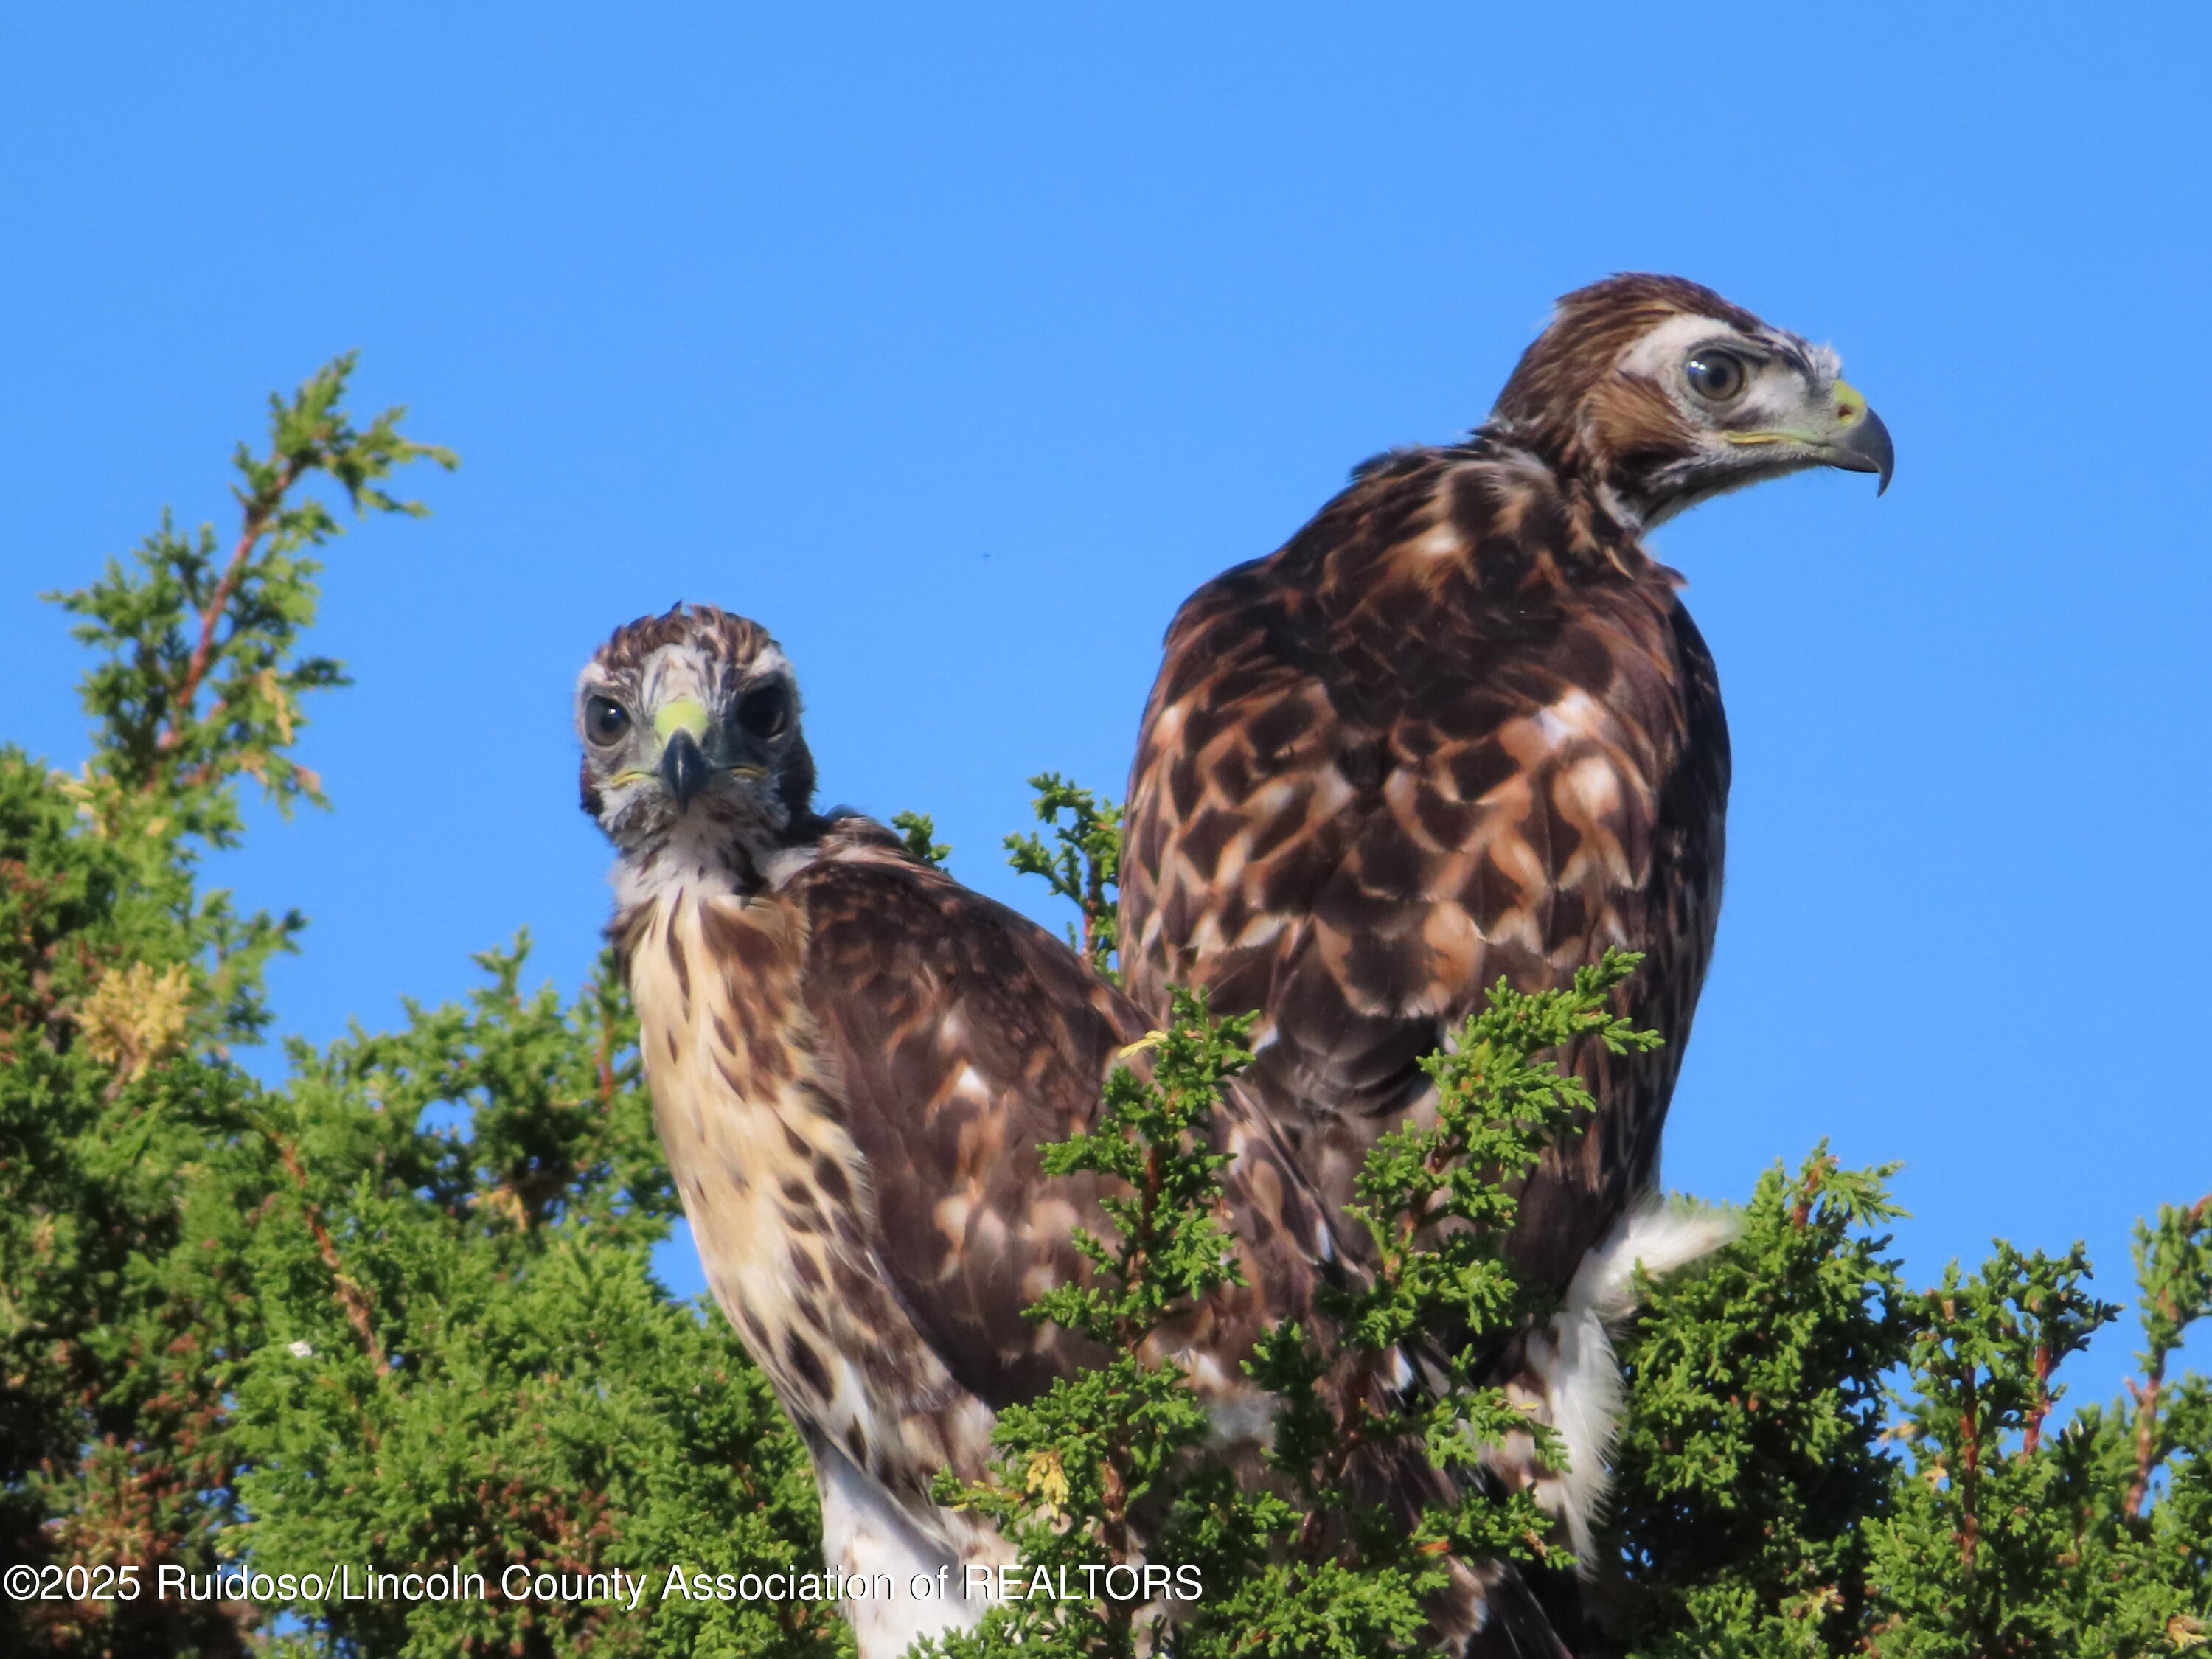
[{"x1": 1491, "y1": 276, "x2": 1896, "y2": 526}]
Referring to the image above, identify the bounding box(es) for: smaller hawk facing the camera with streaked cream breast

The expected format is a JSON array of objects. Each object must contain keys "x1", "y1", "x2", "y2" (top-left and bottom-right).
[{"x1": 577, "y1": 606, "x2": 1557, "y2": 1659}]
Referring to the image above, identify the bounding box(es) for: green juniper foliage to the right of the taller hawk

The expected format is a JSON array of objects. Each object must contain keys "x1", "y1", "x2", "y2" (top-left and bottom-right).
[{"x1": 1608, "y1": 1177, "x2": 2212, "y2": 1659}]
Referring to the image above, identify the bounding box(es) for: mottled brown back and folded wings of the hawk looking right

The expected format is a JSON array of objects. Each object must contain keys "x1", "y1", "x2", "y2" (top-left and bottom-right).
[{"x1": 1121, "y1": 438, "x2": 1728, "y2": 1287}]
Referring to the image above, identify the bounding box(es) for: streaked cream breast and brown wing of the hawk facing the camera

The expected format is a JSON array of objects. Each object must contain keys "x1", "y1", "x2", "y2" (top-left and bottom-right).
[{"x1": 624, "y1": 818, "x2": 1334, "y2": 1513}]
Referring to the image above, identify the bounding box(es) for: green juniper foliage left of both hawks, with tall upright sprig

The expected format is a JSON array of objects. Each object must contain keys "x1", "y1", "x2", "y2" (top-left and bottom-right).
[{"x1": 0, "y1": 358, "x2": 849, "y2": 1657}]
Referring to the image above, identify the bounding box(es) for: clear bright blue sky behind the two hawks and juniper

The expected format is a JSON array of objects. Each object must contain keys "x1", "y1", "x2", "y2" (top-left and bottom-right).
[{"x1": 0, "y1": 4, "x2": 2212, "y2": 1398}]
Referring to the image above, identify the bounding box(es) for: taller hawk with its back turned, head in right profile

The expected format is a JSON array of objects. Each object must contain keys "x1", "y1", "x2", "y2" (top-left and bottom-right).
[{"x1": 1119, "y1": 276, "x2": 1893, "y2": 1575}]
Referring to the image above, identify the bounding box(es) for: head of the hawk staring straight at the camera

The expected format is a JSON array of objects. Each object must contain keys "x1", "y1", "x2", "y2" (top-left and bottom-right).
[{"x1": 575, "y1": 602, "x2": 814, "y2": 880}]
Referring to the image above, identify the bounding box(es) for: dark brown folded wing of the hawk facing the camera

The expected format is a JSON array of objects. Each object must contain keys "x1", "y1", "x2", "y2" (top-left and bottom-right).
[{"x1": 787, "y1": 818, "x2": 1334, "y2": 1409}]
